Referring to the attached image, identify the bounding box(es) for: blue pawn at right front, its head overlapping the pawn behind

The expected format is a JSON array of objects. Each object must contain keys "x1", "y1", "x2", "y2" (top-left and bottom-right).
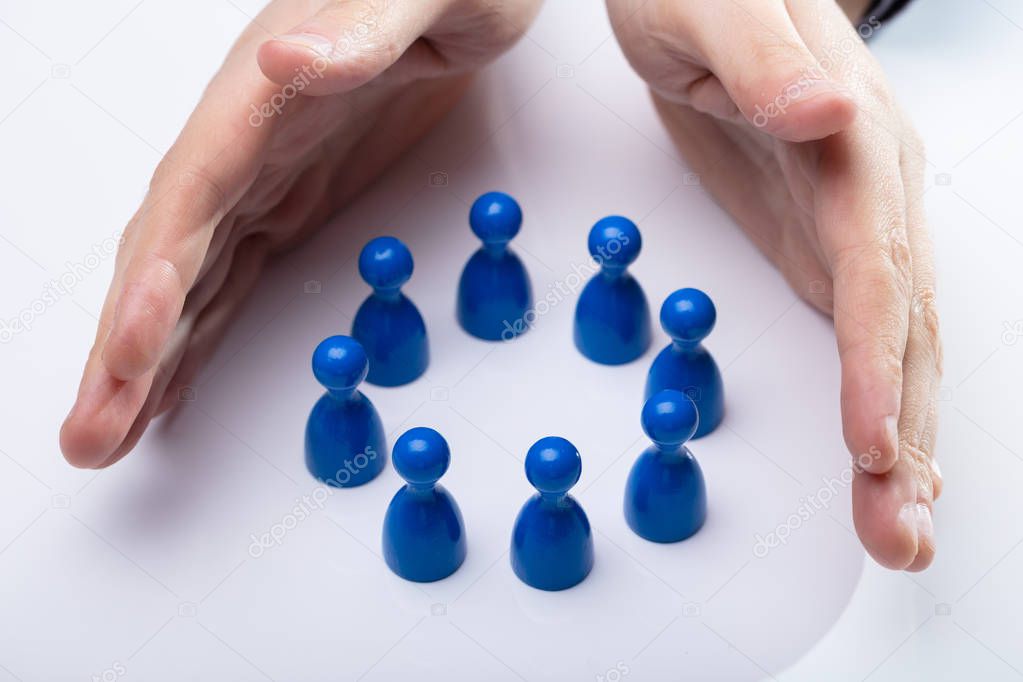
[{"x1": 625, "y1": 389, "x2": 707, "y2": 542}]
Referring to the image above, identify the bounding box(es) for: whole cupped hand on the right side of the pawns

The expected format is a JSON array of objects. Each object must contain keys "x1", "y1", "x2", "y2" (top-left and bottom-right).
[{"x1": 608, "y1": 0, "x2": 941, "y2": 571}]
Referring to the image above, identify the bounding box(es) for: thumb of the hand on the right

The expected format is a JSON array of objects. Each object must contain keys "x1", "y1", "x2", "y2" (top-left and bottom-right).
[{"x1": 676, "y1": 0, "x2": 856, "y2": 142}]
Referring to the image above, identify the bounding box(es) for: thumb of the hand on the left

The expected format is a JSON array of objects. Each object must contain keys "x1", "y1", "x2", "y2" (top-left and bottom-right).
[{"x1": 257, "y1": 0, "x2": 444, "y2": 95}]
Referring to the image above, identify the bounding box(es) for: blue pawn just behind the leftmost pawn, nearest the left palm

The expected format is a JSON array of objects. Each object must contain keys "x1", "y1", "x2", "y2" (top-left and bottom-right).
[{"x1": 352, "y1": 237, "x2": 430, "y2": 387}]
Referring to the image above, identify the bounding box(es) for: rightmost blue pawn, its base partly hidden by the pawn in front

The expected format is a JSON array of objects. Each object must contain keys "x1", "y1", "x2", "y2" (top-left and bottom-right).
[{"x1": 644, "y1": 288, "x2": 724, "y2": 438}]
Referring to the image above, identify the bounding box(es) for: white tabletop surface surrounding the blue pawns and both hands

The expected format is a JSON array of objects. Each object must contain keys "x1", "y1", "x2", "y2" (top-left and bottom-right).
[{"x1": 0, "y1": 0, "x2": 1023, "y2": 681}]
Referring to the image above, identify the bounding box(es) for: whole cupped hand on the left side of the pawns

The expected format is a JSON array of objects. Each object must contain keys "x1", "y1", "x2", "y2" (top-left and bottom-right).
[{"x1": 60, "y1": 0, "x2": 539, "y2": 467}]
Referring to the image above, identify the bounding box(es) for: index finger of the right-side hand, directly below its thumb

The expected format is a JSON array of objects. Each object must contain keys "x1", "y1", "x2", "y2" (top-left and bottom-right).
[{"x1": 816, "y1": 126, "x2": 913, "y2": 473}]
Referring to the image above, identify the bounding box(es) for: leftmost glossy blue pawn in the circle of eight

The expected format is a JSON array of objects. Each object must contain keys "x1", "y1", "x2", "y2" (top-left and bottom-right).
[{"x1": 306, "y1": 336, "x2": 387, "y2": 488}]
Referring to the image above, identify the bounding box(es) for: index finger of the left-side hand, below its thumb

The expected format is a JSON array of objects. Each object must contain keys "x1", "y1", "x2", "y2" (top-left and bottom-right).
[{"x1": 103, "y1": 66, "x2": 273, "y2": 380}]
